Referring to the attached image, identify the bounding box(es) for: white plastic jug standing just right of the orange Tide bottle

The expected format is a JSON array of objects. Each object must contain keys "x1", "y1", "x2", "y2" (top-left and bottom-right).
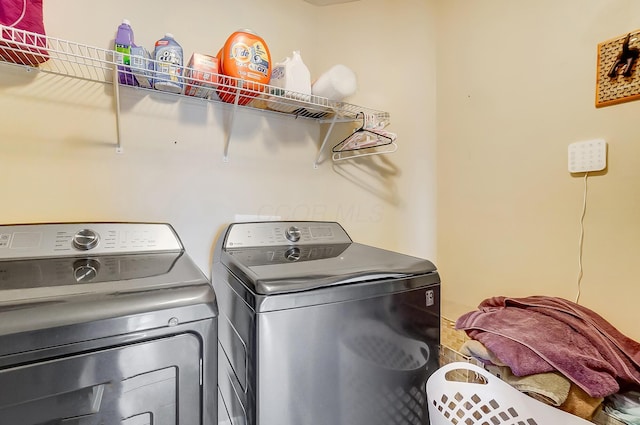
[{"x1": 269, "y1": 50, "x2": 311, "y2": 112}]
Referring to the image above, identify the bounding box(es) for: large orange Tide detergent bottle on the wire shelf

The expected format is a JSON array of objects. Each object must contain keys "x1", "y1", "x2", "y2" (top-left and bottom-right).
[{"x1": 217, "y1": 29, "x2": 272, "y2": 105}]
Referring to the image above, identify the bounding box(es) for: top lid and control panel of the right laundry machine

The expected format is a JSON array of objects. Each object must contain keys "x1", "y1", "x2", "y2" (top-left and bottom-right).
[{"x1": 220, "y1": 222, "x2": 436, "y2": 295}]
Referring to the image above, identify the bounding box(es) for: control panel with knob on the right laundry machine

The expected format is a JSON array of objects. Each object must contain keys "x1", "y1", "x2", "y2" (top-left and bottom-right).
[{"x1": 224, "y1": 221, "x2": 352, "y2": 249}]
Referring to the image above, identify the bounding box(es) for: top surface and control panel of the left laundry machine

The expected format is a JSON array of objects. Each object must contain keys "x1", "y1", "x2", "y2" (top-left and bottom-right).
[{"x1": 0, "y1": 223, "x2": 214, "y2": 336}]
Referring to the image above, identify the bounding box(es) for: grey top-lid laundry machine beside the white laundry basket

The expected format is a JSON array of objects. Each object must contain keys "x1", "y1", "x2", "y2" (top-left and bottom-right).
[{"x1": 211, "y1": 221, "x2": 440, "y2": 425}]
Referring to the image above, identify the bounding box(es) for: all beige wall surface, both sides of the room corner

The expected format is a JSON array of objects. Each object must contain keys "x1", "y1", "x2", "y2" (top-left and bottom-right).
[{"x1": 8, "y1": 0, "x2": 640, "y2": 338}]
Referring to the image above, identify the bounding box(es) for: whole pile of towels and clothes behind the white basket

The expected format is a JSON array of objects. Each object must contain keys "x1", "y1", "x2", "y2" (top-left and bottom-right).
[{"x1": 456, "y1": 296, "x2": 640, "y2": 425}]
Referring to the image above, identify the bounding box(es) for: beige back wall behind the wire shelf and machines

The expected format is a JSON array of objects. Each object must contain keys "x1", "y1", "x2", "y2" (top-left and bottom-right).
[{"x1": 0, "y1": 0, "x2": 436, "y2": 274}]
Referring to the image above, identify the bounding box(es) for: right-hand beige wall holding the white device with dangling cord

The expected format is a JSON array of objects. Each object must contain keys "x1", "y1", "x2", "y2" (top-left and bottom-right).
[{"x1": 437, "y1": 0, "x2": 640, "y2": 339}]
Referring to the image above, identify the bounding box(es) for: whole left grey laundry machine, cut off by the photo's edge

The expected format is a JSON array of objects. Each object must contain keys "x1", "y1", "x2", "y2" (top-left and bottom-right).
[{"x1": 0, "y1": 223, "x2": 218, "y2": 425}]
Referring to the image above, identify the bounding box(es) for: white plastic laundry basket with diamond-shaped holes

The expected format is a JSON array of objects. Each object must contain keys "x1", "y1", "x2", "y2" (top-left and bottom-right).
[{"x1": 427, "y1": 362, "x2": 593, "y2": 425}]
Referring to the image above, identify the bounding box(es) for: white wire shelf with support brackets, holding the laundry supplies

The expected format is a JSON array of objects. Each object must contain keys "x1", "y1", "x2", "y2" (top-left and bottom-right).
[{"x1": 0, "y1": 25, "x2": 390, "y2": 167}]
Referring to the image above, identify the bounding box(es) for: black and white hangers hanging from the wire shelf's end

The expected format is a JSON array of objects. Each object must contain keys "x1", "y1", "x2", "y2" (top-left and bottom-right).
[{"x1": 332, "y1": 112, "x2": 398, "y2": 161}]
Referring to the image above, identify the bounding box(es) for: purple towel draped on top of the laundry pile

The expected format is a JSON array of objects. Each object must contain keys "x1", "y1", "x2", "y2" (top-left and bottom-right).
[{"x1": 456, "y1": 296, "x2": 640, "y2": 397}]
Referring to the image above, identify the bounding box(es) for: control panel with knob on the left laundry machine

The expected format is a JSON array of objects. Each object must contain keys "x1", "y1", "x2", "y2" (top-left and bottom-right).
[{"x1": 0, "y1": 223, "x2": 183, "y2": 260}]
